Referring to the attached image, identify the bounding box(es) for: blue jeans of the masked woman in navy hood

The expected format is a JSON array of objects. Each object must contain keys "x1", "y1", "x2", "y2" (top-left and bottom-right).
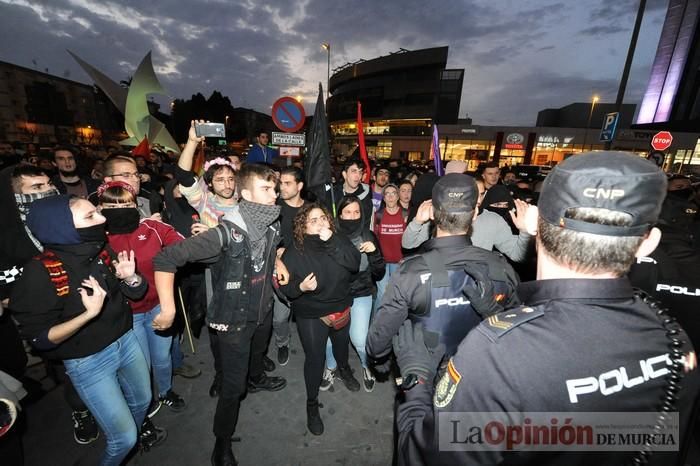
[{"x1": 63, "y1": 330, "x2": 151, "y2": 466}]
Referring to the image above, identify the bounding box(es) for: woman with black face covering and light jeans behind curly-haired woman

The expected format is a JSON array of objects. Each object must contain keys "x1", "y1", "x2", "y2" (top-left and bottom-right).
[{"x1": 319, "y1": 195, "x2": 386, "y2": 392}]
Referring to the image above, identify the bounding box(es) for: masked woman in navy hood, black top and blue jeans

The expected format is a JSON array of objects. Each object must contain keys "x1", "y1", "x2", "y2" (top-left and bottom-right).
[{"x1": 10, "y1": 195, "x2": 165, "y2": 465}]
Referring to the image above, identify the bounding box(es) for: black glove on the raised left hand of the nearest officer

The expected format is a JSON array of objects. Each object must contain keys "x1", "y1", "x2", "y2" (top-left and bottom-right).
[{"x1": 392, "y1": 320, "x2": 445, "y2": 382}]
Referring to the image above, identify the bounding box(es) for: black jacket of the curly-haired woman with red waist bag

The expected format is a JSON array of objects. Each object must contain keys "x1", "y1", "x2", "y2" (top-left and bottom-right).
[{"x1": 280, "y1": 232, "x2": 360, "y2": 319}]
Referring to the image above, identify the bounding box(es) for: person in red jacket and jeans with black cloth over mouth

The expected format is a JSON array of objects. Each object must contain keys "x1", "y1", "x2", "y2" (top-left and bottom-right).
[{"x1": 97, "y1": 181, "x2": 186, "y2": 415}]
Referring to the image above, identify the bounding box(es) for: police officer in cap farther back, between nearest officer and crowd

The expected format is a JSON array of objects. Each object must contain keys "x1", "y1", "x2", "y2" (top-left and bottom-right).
[{"x1": 367, "y1": 173, "x2": 518, "y2": 358}]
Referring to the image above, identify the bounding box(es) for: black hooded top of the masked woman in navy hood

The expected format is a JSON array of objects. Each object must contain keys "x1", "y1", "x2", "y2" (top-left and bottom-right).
[{"x1": 10, "y1": 243, "x2": 148, "y2": 359}]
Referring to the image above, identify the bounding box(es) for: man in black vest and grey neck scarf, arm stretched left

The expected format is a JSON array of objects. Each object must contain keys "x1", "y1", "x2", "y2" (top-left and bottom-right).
[{"x1": 153, "y1": 164, "x2": 288, "y2": 466}]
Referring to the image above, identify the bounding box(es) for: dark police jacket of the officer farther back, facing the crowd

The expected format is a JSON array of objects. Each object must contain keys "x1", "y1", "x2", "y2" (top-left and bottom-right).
[{"x1": 367, "y1": 235, "x2": 518, "y2": 358}]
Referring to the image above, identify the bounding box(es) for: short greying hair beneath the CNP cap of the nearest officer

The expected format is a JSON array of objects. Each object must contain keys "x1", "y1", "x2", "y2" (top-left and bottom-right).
[{"x1": 537, "y1": 207, "x2": 644, "y2": 276}]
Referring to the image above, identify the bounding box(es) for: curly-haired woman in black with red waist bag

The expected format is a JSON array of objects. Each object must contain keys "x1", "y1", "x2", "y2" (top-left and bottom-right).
[{"x1": 281, "y1": 203, "x2": 360, "y2": 435}]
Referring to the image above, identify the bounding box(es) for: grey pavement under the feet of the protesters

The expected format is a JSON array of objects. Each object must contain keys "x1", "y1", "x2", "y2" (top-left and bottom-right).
[{"x1": 24, "y1": 326, "x2": 394, "y2": 466}]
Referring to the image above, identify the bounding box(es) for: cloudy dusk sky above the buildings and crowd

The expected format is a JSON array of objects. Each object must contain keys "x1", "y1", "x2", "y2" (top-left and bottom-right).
[{"x1": 0, "y1": 0, "x2": 668, "y2": 125}]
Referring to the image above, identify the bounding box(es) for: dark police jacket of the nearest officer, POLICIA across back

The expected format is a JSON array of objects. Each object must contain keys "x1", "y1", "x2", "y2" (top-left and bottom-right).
[{"x1": 397, "y1": 278, "x2": 699, "y2": 465}]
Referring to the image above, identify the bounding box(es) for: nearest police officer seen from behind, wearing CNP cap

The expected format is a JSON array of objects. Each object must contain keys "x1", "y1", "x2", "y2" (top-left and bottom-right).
[{"x1": 394, "y1": 152, "x2": 700, "y2": 465}]
